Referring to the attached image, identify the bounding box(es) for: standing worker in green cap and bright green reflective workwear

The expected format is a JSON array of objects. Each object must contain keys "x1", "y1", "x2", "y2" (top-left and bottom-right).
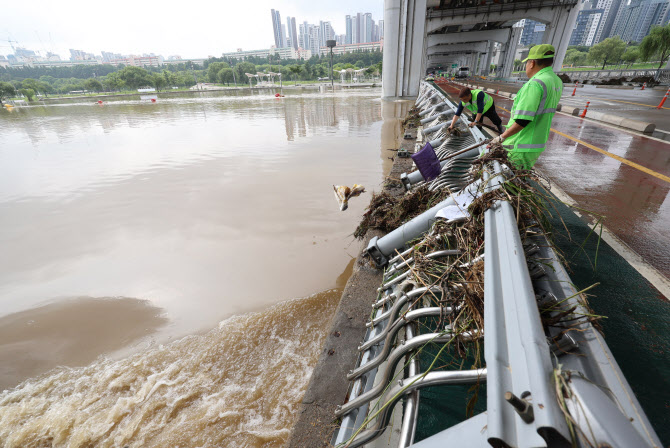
[{"x1": 489, "y1": 44, "x2": 563, "y2": 170}]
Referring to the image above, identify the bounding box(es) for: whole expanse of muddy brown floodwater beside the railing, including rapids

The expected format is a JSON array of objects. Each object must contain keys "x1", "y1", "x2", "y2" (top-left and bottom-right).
[{"x1": 0, "y1": 89, "x2": 409, "y2": 447}]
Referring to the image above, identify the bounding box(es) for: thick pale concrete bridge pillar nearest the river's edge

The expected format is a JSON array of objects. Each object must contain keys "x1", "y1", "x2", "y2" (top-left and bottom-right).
[{"x1": 382, "y1": 0, "x2": 426, "y2": 98}]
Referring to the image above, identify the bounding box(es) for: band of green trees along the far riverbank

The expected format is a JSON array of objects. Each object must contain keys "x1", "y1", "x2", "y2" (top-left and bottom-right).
[{"x1": 0, "y1": 51, "x2": 382, "y2": 101}]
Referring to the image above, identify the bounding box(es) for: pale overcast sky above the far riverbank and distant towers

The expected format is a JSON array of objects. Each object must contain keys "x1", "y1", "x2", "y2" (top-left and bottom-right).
[{"x1": 0, "y1": 0, "x2": 384, "y2": 59}]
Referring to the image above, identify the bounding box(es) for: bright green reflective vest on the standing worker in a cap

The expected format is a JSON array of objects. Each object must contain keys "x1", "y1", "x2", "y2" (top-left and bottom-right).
[{"x1": 503, "y1": 67, "x2": 563, "y2": 153}]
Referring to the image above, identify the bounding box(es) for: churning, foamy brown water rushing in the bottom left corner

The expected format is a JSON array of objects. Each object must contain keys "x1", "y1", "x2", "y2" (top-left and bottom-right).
[{"x1": 0, "y1": 290, "x2": 340, "y2": 448}]
